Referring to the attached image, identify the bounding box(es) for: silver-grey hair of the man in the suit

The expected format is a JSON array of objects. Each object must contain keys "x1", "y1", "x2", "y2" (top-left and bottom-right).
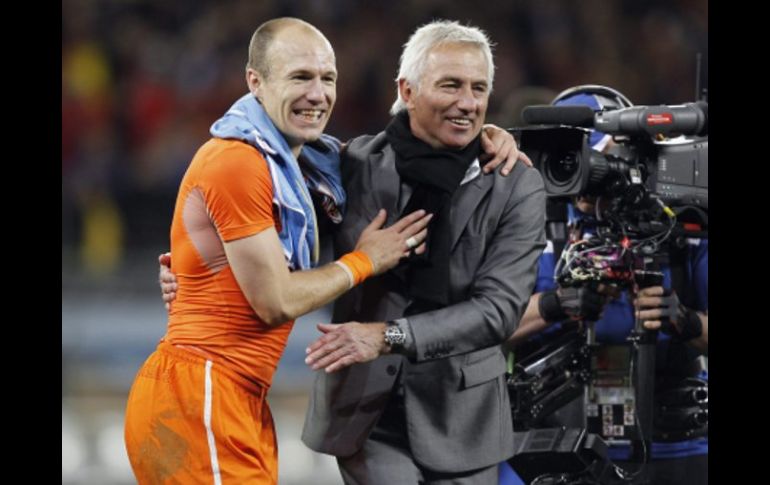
[{"x1": 390, "y1": 20, "x2": 495, "y2": 115}]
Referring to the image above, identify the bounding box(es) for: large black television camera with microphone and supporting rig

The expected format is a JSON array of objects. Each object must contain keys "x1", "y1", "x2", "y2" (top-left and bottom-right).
[{"x1": 508, "y1": 85, "x2": 708, "y2": 484}]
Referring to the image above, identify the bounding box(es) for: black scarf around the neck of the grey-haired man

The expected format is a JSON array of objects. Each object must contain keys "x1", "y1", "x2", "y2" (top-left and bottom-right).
[{"x1": 385, "y1": 110, "x2": 481, "y2": 315}]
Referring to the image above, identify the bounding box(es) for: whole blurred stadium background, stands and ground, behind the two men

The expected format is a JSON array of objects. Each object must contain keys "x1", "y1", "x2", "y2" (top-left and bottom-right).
[{"x1": 62, "y1": 0, "x2": 708, "y2": 485}]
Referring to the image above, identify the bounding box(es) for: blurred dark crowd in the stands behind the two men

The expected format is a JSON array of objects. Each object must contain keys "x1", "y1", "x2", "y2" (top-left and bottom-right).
[{"x1": 62, "y1": 0, "x2": 708, "y2": 274}]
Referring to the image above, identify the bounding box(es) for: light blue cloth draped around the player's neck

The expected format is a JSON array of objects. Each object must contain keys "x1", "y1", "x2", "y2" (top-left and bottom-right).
[{"x1": 211, "y1": 93, "x2": 345, "y2": 270}]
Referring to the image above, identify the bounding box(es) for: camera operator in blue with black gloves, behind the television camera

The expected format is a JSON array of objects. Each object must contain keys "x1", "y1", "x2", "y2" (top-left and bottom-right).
[{"x1": 501, "y1": 89, "x2": 708, "y2": 485}]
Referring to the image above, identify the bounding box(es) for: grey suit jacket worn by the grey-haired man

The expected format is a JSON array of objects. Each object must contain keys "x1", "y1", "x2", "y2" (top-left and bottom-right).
[{"x1": 302, "y1": 133, "x2": 545, "y2": 472}]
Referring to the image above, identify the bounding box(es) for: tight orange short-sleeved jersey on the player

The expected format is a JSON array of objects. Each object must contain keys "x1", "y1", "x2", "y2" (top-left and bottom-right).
[{"x1": 165, "y1": 138, "x2": 294, "y2": 387}]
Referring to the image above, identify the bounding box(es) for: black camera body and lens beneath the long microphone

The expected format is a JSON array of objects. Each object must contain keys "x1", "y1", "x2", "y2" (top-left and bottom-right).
[{"x1": 516, "y1": 126, "x2": 708, "y2": 237}]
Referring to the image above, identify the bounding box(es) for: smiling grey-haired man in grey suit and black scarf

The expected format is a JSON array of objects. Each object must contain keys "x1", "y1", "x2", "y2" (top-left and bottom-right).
[{"x1": 303, "y1": 21, "x2": 545, "y2": 485}]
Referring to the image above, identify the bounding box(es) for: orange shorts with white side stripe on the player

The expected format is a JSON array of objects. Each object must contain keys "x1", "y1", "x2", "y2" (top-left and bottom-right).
[{"x1": 125, "y1": 342, "x2": 278, "y2": 485}]
